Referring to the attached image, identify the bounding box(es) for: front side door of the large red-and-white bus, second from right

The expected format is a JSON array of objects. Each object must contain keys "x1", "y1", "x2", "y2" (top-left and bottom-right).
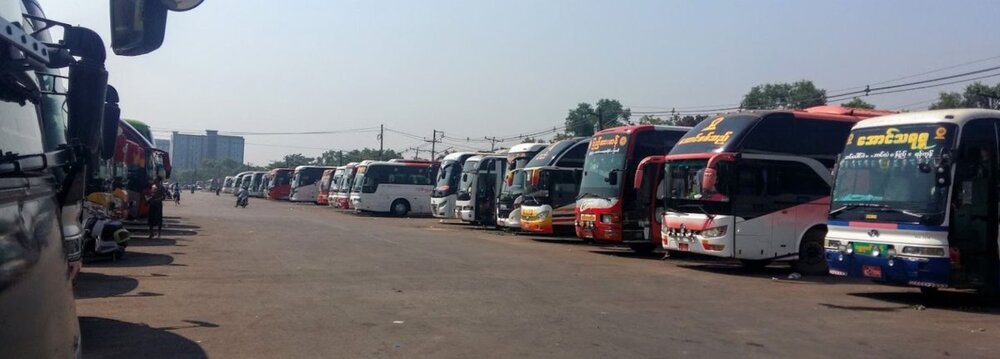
[{"x1": 729, "y1": 160, "x2": 776, "y2": 259}]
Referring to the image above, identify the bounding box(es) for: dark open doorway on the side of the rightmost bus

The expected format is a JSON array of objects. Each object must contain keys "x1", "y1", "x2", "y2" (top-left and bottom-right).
[{"x1": 948, "y1": 119, "x2": 998, "y2": 287}]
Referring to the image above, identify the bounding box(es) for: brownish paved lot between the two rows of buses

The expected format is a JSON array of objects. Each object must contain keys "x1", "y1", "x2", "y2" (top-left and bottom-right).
[{"x1": 76, "y1": 193, "x2": 1000, "y2": 358}]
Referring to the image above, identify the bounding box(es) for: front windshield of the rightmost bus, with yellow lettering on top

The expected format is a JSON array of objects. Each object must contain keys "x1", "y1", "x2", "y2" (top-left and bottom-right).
[{"x1": 830, "y1": 124, "x2": 955, "y2": 225}]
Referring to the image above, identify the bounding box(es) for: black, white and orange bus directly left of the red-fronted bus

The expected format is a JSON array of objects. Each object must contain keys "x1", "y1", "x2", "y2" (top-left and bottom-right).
[{"x1": 512, "y1": 137, "x2": 590, "y2": 234}]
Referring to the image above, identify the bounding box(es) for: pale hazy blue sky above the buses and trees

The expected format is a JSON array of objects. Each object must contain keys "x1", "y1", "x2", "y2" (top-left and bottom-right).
[{"x1": 43, "y1": 0, "x2": 1000, "y2": 164}]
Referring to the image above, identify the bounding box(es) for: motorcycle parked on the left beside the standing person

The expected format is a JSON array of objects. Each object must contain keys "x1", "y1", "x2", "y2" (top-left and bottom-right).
[{"x1": 83, "y1": 201, "x2": 132, "y2": 260}]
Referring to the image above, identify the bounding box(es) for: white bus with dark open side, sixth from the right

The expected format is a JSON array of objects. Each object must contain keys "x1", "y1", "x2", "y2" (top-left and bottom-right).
[{"x1": 455, "y1": 155, "x2": 507, "y2": 225}]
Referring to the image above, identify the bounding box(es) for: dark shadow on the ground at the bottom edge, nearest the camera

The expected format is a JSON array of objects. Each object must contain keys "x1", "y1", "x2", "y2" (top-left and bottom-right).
[{"x1": 80, "y1": 317, "x2": 213, "y2": 358}]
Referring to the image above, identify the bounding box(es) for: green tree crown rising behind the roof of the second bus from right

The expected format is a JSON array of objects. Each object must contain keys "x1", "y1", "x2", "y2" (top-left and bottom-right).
[{"x1": 740, "y1": 80, "x2": 826, "y2": 110}]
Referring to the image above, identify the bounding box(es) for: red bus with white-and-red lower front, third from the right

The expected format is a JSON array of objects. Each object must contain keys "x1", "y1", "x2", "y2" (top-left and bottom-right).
[{"x1": 575, "y1": 125, "x2": 689, "y2": 251}]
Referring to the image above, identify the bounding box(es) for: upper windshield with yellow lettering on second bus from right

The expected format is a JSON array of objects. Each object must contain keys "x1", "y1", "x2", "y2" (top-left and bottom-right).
[{"x1": 670, "y1": 114, "x2": 760, "y2": 155}]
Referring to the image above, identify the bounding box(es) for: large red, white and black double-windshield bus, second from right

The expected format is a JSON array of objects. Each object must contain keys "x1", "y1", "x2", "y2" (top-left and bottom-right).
[{"x1": 661, "y1": 106, "x2": 888, "y2": 274}]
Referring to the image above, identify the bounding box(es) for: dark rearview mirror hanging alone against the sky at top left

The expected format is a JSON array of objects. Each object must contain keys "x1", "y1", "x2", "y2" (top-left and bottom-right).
[{"x1": 111, "y1": 0, "x2": 167, "y2": 56}]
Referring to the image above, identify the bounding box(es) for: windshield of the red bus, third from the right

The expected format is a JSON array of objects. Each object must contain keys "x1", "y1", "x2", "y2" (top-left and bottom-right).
[{"x1": 580, "y1": 133, "x2": 630, "y2": 199}]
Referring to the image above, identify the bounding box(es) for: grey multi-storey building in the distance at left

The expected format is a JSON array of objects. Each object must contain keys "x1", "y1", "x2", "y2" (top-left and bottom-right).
[{"x1": 170, "y1": 130, "x2": 244, "y2": 169}]
